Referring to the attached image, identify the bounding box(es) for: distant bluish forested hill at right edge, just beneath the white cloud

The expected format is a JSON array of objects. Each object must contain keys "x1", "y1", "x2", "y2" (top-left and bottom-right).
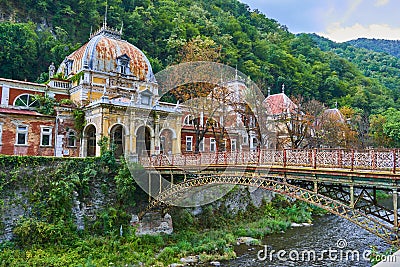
[{"x1": 346, "y1": 38, "x2": 400, "y2": 58}]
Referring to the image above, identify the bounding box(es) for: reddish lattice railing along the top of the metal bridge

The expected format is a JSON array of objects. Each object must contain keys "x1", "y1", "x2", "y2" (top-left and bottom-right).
[{"x1": 140, "y1": 149, "x2": 400, "y2": 173}]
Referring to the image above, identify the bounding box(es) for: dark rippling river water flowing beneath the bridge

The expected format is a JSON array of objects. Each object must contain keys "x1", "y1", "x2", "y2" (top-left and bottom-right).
[{"x1": 221, "y1": 215, "x2": 392, "y2": 267}]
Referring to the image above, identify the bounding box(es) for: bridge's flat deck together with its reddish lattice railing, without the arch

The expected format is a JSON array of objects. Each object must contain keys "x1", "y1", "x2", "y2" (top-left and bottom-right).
[{"x1": 141, "y1": 149, "x2": 400, "y2": 189}]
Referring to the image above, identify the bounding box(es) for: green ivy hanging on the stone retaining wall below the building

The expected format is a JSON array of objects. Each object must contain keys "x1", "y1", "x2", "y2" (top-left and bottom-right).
[{"x1": 0, "y1": 153, "x2": 136, "y2": 246}]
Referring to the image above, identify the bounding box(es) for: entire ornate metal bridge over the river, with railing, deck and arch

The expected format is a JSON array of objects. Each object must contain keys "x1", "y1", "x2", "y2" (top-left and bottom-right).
[{"x1": 140, "y1": 149, "x2": 400, "y2": 245}]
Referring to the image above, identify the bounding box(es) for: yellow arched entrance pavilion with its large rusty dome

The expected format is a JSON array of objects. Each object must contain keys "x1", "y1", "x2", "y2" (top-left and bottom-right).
[{"x1": 49, "y1": 24, "x2": 182, "y2": 157}]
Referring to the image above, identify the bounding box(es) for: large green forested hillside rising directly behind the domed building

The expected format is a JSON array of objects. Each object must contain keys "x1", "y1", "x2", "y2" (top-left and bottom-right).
[{"x1": 0, "y1": 0, "x2": 399, "y2": 114}]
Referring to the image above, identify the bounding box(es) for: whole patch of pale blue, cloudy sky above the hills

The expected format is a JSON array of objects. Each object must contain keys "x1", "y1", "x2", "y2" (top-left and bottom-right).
[{"x1": 240, "y1": 0, "x2": 400, "y2": 42}]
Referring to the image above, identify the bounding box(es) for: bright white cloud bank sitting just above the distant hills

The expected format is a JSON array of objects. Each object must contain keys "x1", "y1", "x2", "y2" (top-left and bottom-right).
[{"x1": 318, "y1": 23, "x2": 400, "y2": 42}]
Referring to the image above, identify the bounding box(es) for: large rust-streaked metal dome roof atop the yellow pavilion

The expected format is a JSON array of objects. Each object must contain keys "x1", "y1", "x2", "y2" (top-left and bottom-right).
[{"x1": 58, "y1": 26, "x2": 155, "y2": 82}]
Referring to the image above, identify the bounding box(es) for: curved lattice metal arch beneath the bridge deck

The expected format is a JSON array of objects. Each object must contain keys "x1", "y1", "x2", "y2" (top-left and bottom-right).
[{"x1": 139, "y1": 175, "x2": 399, "y2": 244}]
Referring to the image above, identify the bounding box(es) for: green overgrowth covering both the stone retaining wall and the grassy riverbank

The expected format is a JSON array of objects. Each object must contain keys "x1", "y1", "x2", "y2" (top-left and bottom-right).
[{"x1": 0, "y1": 152, "x2": 332, "y2": 266}]
